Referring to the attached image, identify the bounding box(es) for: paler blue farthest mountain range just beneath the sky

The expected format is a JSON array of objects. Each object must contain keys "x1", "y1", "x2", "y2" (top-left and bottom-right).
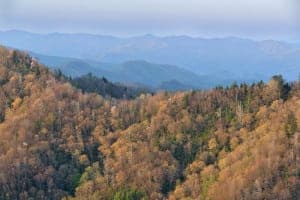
[{"x1": 0, "y1": 31, "x2": 300, "y2": 87}]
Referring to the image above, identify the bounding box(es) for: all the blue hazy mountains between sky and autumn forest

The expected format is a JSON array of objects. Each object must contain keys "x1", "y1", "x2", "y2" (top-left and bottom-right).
[{"x1": 0, "y1": 31, "x2": 300, "y2": 88}]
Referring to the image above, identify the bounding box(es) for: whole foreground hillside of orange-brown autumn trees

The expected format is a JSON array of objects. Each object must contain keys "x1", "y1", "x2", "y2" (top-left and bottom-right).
[{"x1": 0, "y1": 48, "x2": 300, "y2": 200}]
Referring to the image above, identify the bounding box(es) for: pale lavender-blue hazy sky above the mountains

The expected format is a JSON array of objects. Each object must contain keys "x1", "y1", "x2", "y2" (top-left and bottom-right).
[{"x1": 0, "y1": 0, "x2": 300, "y2": 39}]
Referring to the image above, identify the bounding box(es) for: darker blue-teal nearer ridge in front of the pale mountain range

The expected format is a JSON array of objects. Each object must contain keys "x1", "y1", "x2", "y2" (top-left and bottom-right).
[{"x1": 31, "y1": 53, "x2": 217, "y2": 90}]
